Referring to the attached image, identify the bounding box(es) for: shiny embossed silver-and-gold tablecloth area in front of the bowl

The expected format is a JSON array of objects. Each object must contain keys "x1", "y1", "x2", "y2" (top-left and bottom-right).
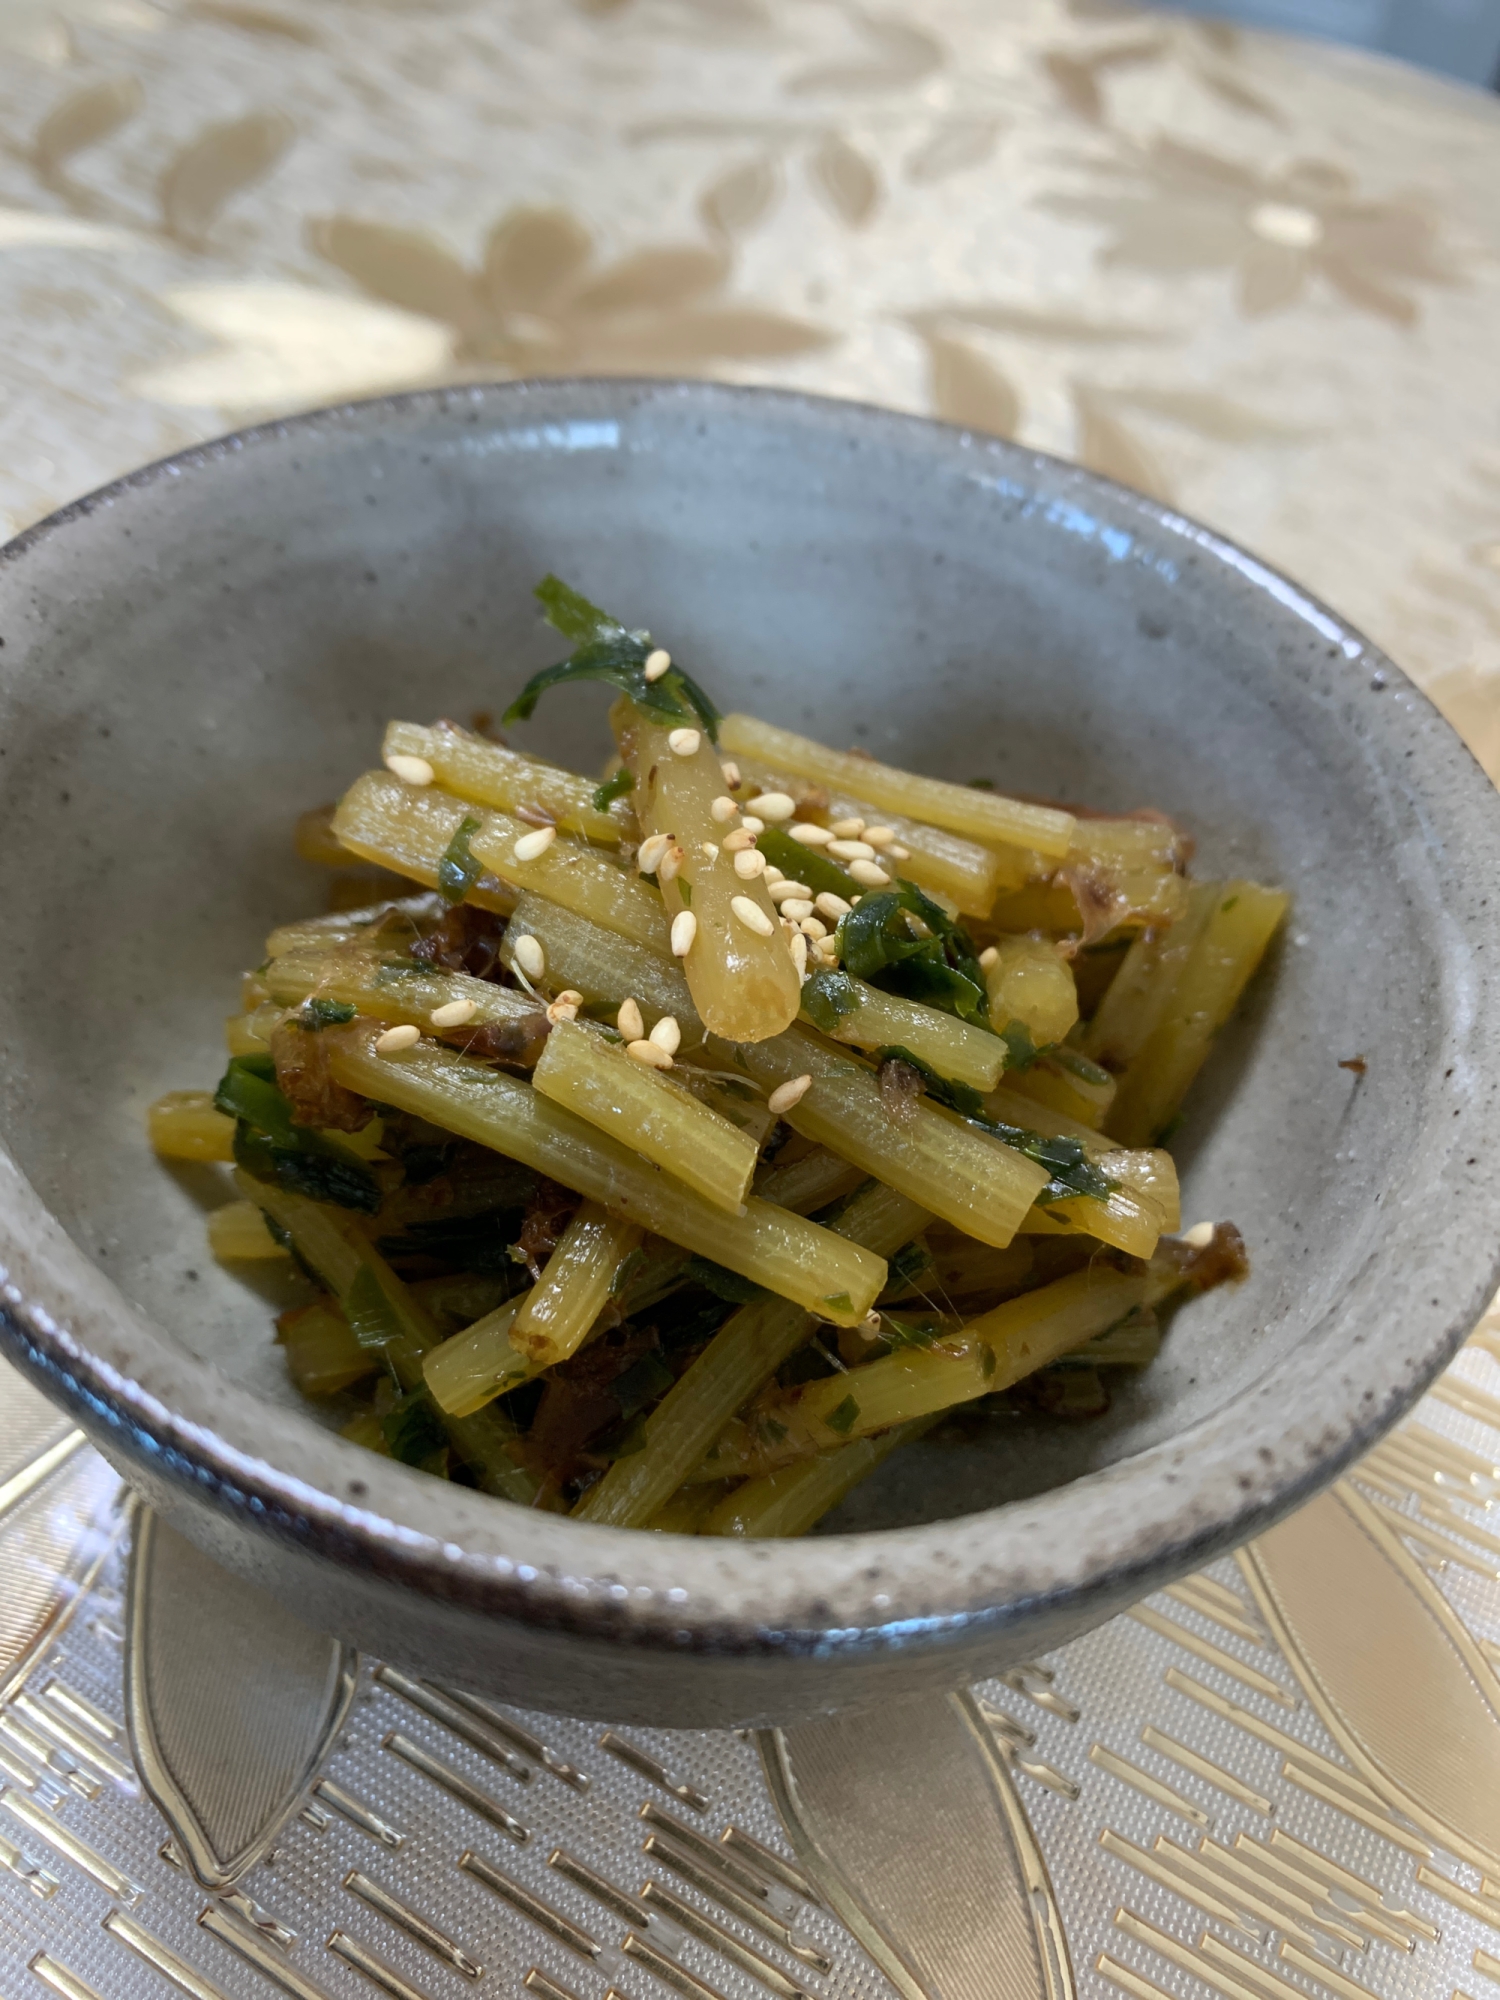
[{"x1": 0, "y1": 1326, "x2": 1500, "y2": 2000}]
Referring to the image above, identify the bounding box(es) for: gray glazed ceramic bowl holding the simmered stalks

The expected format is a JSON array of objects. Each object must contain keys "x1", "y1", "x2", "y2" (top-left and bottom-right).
[{"x1": 0, "y1": 382, "x2": 1500, "y2": 1726}]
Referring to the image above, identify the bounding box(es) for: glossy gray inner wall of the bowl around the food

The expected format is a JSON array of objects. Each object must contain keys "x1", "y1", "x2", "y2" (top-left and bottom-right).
[{"x1": 0, "y1": 388, "x2": 1464, "y2": 1528}]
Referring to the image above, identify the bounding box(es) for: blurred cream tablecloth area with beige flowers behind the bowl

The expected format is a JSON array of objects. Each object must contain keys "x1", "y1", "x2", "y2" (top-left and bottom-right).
[{"x1": 0, "y1": 0, "x2": 1500, "y2": 770}]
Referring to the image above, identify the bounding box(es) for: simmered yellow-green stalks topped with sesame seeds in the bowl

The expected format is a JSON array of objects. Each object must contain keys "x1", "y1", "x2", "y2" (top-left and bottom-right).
[{"x1": 150, "y1": 578, "x2": 1286, "y2": 1536}]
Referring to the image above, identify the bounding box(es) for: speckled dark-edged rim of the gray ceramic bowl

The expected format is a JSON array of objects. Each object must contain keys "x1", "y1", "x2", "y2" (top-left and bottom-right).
[{"x1": 0, "y1": 380, "x2": 1500, "y2": 1660}]
